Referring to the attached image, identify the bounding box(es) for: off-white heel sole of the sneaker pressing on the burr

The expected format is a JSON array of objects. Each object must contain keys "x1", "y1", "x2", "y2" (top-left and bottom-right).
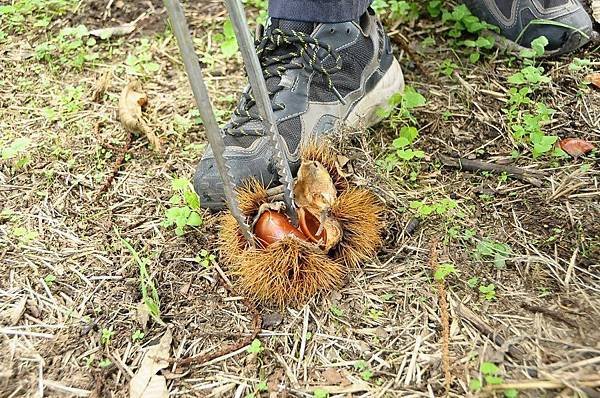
[{"x1": 345, "y1": 58, "x2": 404, "y2": 128}]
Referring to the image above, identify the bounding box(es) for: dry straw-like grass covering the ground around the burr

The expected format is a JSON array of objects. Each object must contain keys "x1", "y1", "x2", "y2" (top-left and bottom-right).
[{"x1": 0, "y1": 1, "x2": 600, "y2": 397}]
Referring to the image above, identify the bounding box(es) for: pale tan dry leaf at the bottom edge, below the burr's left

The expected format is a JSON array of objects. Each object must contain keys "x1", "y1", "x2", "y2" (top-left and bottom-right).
[{"x1": 129, "y1": 328, "x2": 173, "y2": 398}]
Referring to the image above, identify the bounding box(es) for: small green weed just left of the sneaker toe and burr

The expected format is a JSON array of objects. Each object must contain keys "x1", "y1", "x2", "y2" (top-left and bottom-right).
[{"x1": 161, "y1": 178, "x2": 202, "y2": 236}]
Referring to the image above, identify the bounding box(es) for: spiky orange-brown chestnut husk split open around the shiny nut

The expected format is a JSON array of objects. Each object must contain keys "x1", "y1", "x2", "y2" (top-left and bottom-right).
[{"x1": 219, "y1": 143, "x2": 384, "y2": 306}]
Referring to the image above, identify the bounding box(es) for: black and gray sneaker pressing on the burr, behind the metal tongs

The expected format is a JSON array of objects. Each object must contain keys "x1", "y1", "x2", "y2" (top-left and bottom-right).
[{"x1": 194, "y1": 10, "x2": 404, "y2": 209}]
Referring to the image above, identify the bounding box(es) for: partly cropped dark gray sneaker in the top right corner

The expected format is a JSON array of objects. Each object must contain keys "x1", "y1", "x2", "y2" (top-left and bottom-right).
[{"x1": 463, "y1": 0, "x2": 594, "y2": 56}]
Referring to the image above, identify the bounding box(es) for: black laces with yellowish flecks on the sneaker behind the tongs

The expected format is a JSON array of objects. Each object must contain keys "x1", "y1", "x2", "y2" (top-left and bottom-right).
[{"x1": 225, "y1": 28, "x2": 344, "y2": 136}]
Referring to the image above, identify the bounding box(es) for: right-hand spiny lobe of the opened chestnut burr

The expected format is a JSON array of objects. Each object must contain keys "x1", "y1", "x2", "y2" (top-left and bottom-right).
[{"x1": 331, "y1": 188, "x2": 385, "y2": 268}]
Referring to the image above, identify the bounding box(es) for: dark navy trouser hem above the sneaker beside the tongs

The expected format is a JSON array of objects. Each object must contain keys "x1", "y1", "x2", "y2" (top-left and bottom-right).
[{"x1": 269, "y1": 0, "x2": 371, "y2": 23}]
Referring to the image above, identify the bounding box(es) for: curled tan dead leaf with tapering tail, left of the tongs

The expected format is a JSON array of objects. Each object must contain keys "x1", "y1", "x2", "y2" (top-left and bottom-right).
[{"x1": 119, "y1": 80, "x2": 161, "y2": 151}]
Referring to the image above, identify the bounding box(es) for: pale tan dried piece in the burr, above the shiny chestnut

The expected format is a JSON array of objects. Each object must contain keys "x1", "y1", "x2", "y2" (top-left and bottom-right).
[{"x1": 294, "y1": 160, "x2": 337, "y2": 217}]
